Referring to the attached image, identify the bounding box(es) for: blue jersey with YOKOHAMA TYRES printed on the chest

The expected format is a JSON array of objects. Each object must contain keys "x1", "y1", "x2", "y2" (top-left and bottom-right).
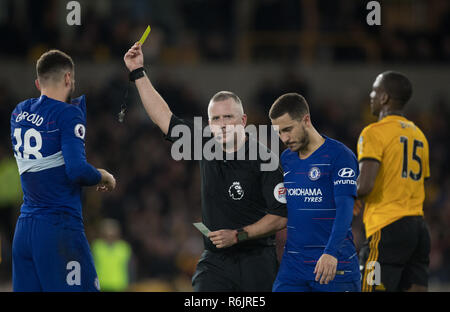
[{"x1": 281, "y1": 136, "x2": 359, "y2": 280}]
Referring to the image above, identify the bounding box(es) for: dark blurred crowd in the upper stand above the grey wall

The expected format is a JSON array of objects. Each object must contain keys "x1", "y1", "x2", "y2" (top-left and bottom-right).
[{"x1": 0, "y1": 0, "x2": 450, "y2": 63}]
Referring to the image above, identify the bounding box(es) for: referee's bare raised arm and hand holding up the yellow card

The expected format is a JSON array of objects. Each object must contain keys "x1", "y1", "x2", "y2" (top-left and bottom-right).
[{"x1": 123, "y1": 42, "x2": 172, "y2": 134}]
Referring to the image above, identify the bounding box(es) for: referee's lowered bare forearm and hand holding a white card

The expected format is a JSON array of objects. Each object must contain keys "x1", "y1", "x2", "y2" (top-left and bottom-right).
[{"x1": 208, "y1": 214, "x2": 287, "y2": 248}]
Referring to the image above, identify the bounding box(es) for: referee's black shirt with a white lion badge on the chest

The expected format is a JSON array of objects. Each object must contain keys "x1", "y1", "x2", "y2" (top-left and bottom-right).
[{"x1": 166, "y1": 115, "x2": 287, "y2": 251}]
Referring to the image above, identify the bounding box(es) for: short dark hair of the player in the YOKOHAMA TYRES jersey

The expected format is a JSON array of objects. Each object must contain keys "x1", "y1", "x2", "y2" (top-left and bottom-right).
[{"x1": 269, "y1": 93, "x2": 309, "y2": 120}]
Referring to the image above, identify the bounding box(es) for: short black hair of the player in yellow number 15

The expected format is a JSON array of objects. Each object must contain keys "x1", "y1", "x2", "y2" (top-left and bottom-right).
[{"x1": 381, "y1": 70, "x2": 412, "y2": 108}]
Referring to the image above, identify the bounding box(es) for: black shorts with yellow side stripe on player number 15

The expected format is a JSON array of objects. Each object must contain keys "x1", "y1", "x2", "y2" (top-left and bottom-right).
[{"x1": 359, "y1": 216, "x2": 430, "y2": 292}]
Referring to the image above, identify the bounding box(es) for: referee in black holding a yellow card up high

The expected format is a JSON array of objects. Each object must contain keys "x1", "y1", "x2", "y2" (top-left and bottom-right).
[{"x1": 124, "y1": 43, "x2": 287, "y2": 292}]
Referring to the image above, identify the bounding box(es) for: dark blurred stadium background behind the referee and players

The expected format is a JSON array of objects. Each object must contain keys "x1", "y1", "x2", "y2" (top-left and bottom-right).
[{"x1": 0, "y1": 0, "x2": 450, "y2": 291}]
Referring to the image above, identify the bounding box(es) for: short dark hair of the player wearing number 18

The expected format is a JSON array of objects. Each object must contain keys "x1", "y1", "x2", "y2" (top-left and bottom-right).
[{"x1": 36, "y1": 50, "x2": 75, "y2": 84}]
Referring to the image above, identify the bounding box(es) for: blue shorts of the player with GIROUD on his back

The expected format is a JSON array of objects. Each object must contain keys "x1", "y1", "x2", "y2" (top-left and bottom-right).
[{"x1": 13, "y1": 213, "x2": 100, "y2": 292}]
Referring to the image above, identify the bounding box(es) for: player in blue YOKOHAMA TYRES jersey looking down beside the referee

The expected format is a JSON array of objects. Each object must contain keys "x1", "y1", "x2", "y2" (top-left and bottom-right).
[{"x1": 269, "y1": 93, "x2": 361, "y2": 292}]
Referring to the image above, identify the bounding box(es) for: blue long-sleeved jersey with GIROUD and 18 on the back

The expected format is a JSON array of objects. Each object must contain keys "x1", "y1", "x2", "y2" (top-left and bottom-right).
[{"x1": 11, "y1": 95, "x2": 101, "y2": 219}]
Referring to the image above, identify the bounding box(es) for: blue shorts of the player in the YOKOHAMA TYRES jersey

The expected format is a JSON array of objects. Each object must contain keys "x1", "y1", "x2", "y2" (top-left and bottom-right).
[{"x1": 272, "y1": 278, "x2": 361, "y2": 292}]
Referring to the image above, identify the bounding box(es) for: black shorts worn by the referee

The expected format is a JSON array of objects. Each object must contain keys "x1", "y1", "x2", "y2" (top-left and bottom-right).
[{"x1": 192, "y1": 246, "x2": 278, "y2": 292}]
